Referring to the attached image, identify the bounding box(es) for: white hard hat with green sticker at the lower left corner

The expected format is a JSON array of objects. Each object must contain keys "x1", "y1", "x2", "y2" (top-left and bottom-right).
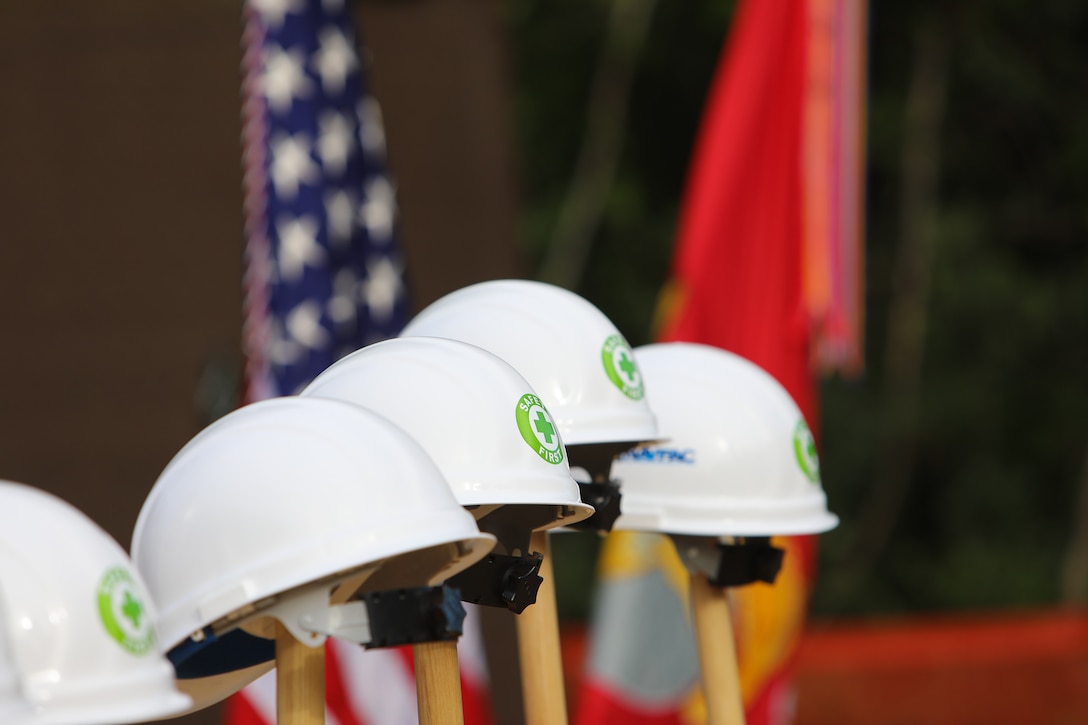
[{"x1": 0, "y1": 481, "x2": 189, "y2": 725}]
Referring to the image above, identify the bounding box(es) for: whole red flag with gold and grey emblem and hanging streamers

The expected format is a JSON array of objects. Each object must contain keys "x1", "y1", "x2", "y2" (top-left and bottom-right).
[{"x1": 573, "y1": 0, "x2": 863, "y2": 725}]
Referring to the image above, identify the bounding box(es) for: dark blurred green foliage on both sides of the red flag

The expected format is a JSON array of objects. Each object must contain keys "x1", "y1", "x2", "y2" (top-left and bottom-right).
[{"x1": 508, "y1": 0, "x2": 1088, "y2": 616}]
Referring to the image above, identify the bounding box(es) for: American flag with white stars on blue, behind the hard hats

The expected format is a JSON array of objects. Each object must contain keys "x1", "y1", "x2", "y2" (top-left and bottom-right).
[{"x1": 233, "y1": 0, "x2": 498, "y2": 725}]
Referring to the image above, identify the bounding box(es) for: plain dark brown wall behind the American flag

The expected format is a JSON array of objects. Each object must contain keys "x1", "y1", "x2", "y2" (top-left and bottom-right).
[{"x1": 0, "y1": 0, "x2": 518, "y2": 724}]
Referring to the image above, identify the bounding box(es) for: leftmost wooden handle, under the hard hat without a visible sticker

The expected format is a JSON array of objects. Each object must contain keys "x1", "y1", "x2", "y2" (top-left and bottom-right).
[{"x1": 275, "y1": 620, "x2": 325, "y2": 725}]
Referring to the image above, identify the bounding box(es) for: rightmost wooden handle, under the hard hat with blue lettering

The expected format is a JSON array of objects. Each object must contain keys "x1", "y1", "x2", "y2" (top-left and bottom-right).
[{"x1": 691, "y1": 572, "x2": 744, "y2": 725}]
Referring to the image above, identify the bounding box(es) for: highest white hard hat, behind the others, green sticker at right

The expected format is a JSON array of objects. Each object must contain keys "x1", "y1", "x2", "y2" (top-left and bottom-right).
[{"x1": 401, "y1": 280, "x2": 657, "y2": 447}]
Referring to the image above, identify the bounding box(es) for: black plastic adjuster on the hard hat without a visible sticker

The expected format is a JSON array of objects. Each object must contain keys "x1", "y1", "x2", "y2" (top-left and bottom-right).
[{"x1": 357, "y1": 586, "x2": 465, "y2": 649}]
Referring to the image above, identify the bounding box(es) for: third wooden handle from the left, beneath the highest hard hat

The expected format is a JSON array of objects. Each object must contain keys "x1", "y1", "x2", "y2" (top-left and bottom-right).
[{"x1": 517, "y1": 524, "x2": 567, "y2": 725}]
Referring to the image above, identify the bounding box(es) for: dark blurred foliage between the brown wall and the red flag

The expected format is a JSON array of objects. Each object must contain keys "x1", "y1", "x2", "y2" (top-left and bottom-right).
[{"x1": 510, "y1": 0, "x2": 732, "y2": 345}]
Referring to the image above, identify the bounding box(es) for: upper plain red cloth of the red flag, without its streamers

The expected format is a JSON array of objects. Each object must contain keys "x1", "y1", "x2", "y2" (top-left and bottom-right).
[{"x1": 659, "y1": 0, "x2": 814, "y2": 421}]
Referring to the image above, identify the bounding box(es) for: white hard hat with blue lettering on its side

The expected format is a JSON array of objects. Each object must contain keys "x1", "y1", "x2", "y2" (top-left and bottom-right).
[{"x1": 613, "y1": 343, "x2": 839, "y2": 537}]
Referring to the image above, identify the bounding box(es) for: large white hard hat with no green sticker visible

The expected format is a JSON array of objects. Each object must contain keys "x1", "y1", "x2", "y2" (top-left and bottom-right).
[{"x1": 133, "y1": 397, "x2": 495, "y2": 708}]
